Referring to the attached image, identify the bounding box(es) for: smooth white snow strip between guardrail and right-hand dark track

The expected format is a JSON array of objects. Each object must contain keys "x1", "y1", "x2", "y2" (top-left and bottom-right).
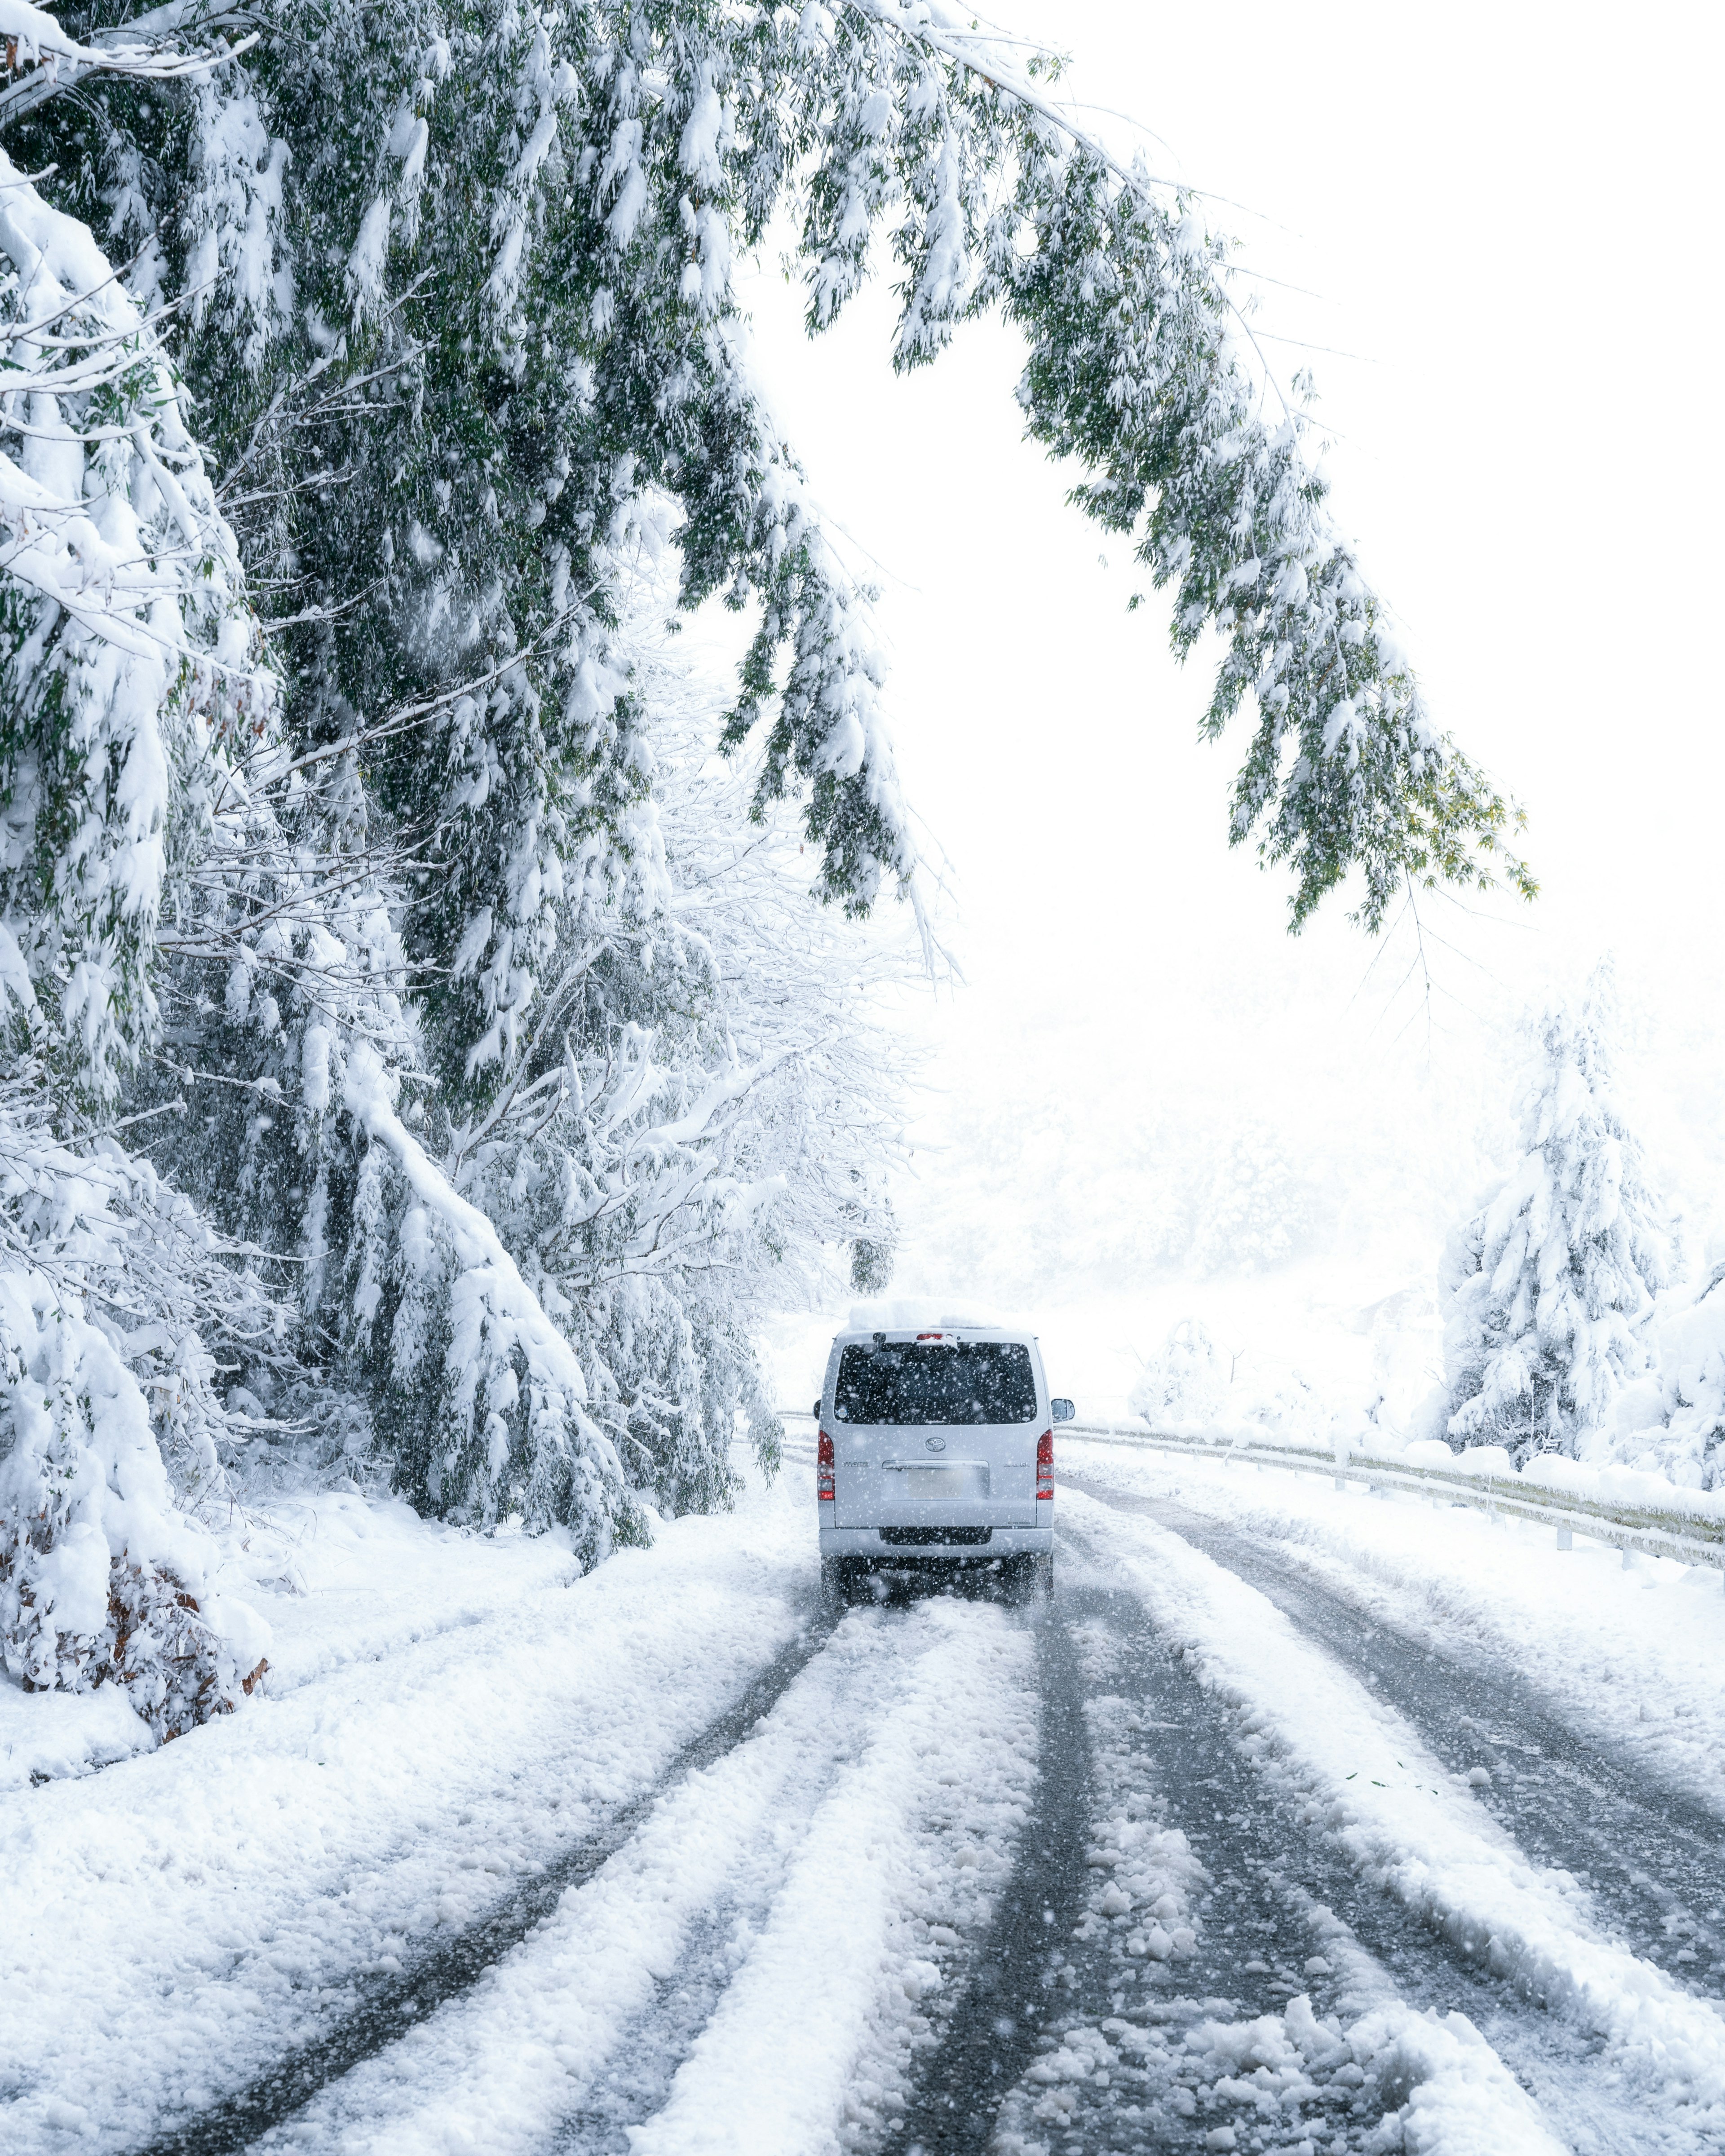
[{"x1": 1057, "y1": 1436, "x2": 1725, "y2": 1813}]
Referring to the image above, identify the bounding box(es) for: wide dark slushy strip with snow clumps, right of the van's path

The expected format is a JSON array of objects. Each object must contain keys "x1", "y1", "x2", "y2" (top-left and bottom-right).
[{"x1": 992, "y1": 1552, "x2": 1557, "y2": 2156}]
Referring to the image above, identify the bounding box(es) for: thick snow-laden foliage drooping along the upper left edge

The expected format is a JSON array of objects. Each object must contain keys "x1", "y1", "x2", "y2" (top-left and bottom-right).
[{"x1": 0, "y1": 151, "x2": 274, "y2": 1097}]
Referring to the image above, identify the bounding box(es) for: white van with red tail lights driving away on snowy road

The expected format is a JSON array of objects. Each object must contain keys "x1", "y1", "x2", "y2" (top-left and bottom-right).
[{"x1": 815, "y1": 1320, "x2": 1072, "y2": 1595}]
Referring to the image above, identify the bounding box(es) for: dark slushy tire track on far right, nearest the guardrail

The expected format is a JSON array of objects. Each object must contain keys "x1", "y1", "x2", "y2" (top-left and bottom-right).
[{"x1": 1067, "y1": 1475, "x2": 1725, "y2": 1999}]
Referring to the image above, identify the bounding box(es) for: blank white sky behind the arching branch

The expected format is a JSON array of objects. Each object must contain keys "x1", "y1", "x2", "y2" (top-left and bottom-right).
[{"x1": 720, "y1": 0, "x2": 1725, "y2": 1397}]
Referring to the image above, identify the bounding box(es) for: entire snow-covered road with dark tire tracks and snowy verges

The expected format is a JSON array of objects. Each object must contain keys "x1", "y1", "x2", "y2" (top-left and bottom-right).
[{"x1": 0, "y1": 1445, "x2": 1725, "y2": 2156}]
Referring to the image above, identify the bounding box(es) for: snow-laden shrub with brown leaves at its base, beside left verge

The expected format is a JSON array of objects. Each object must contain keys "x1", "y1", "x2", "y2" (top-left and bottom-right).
[{"x1": 0, "y1": 1266, "x2": 267, "y2": 1738}]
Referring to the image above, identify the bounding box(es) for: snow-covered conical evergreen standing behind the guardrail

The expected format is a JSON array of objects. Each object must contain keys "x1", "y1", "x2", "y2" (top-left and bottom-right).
[{"x1": 1442, "y1": 966, "x2": 1671, "y2": 1464}]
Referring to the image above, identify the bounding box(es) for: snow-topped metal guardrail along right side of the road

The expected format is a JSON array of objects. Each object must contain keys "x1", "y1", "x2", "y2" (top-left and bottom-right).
[{"x1": 1061, "y1": 1423, "x2": 1725, "y2": 1572}]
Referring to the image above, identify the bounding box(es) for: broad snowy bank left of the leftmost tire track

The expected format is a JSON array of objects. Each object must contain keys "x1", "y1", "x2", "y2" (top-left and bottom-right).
[{"x1": 0, "y1": 1449, "x2": 815, "y2": 2152}]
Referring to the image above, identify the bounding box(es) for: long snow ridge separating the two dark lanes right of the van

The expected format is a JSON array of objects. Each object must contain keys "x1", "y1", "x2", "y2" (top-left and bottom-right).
[{"x1": 1061, "y1": 1475, "x2": 1725, "y2": 2145}]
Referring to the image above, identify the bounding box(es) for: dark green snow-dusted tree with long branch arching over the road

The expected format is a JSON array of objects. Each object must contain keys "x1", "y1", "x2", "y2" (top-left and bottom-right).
[{"x1": 30, "y1": 0, "x2": 1525, "y2": 957}]
